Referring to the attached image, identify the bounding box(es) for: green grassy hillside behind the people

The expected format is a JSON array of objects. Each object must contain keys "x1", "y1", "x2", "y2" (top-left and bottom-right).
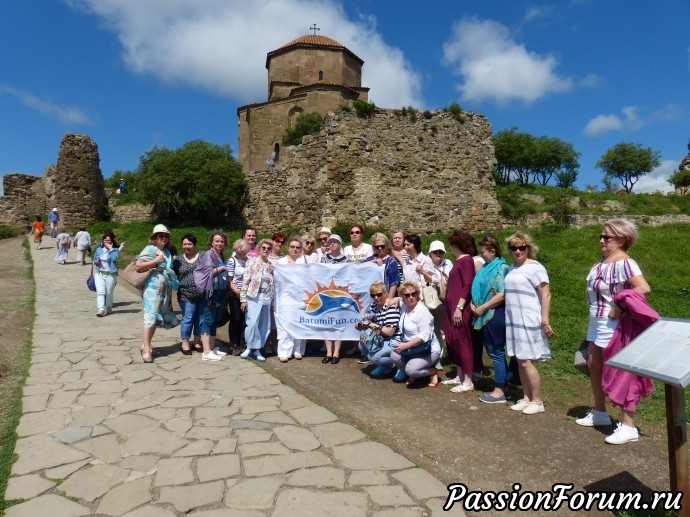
[{"x1": 90, "y1": 223, "x2": 690, "y2": 428}]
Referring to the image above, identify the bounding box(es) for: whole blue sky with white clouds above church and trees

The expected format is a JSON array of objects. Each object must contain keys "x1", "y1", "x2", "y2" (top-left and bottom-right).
[{"x1": 0, "y1": 0, "x2": 690, "y2": 196}]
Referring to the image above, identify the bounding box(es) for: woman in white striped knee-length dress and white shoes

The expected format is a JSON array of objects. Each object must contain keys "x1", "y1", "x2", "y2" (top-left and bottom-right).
[{"x1": 505, "y1": 232, "x2": 556, "y2": 415}]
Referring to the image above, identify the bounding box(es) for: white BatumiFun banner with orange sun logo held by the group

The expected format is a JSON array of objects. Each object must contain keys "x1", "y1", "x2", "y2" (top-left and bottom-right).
[{"x1": 273, "y1": 263, "x2": 383, "y2": 341}]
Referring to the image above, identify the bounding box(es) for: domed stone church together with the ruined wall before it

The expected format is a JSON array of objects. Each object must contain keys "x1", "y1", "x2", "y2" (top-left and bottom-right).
[{"x1": 237, "y1": 35, "x2": 501, "y2": 233}]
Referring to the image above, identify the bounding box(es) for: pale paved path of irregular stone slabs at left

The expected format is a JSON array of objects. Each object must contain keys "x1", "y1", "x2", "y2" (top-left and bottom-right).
[{"x1": 6, "y1": 242, "x2": 464, "y2": 517}]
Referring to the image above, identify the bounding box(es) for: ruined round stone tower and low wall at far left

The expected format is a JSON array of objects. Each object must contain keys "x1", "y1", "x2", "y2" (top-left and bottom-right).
[{"x1": 0, "y1": 133, "x2": 108, "y2": 231}]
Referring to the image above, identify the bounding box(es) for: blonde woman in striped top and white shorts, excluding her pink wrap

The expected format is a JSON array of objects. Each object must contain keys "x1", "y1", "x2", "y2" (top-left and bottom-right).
[{"x1": 575, "y1": 218, "x2": 651, "y2": 444}]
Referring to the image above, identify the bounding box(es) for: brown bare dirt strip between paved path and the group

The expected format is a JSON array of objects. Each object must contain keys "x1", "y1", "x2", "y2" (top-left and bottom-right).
[{"x1": 265, "y1": 348, "x2": 669, "y2": 515}]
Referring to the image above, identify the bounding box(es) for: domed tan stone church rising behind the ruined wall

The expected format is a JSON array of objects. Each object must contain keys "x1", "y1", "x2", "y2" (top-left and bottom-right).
[{"x1": 237, "y1": 35, "x2": 369, "y2": 171}]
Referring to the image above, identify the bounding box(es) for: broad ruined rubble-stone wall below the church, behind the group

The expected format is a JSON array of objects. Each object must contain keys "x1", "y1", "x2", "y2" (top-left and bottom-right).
[{"x1": 246, "y1": 110, "x2": 501, "y2": 233}]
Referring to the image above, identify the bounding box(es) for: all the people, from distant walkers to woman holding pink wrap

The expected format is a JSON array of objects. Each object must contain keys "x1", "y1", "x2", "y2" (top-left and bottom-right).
[{"x1": 33, "y1": 214, "x2": 659, "y2": 444}]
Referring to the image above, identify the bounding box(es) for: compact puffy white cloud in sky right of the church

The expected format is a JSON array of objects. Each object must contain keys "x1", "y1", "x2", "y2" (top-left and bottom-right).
[{"x1": 443, "y1": 18, "x2": 574, "y2": 104}]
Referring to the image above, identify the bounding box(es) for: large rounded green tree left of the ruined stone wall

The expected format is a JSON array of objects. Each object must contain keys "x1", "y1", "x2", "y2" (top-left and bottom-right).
[{"x1": 136, "y1": 140, "x2": 247, "y2": 226}]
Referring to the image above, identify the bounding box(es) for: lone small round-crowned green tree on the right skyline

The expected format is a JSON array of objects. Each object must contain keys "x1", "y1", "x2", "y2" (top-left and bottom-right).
[{"x1": 596, "y1": 142, "x2": 661, "y2": 193}]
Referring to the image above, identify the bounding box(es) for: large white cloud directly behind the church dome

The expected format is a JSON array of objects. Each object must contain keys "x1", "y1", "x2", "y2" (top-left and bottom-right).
[{"x1": 65, "y1": 0, "x2": 423, "y2": 106}]
